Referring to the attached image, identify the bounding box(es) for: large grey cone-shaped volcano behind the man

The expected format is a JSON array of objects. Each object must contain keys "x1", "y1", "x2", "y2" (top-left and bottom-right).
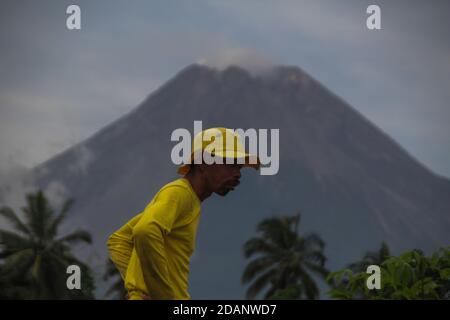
[{"x1": 25, "y1": 64, "x2": 450, "y2": 299}]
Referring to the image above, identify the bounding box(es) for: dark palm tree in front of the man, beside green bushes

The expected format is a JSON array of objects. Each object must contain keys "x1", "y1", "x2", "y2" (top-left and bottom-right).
[{"x1": 242, "y1": 213, "x2": 328, "y2": 299}]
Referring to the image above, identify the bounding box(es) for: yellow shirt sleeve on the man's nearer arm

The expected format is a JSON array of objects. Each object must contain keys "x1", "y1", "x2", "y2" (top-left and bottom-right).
[{"x1": 133, "y1": 186, "x2": 187, "y2": 300}]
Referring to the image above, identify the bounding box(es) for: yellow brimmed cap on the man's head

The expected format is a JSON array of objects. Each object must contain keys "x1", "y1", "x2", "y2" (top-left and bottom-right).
[{"x1": 178, "y1": 128, "x2": 261, "y2": 175}]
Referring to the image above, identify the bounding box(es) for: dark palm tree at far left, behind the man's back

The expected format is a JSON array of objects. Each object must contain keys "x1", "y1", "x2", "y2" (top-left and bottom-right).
[{"x1": 0, "y1": 190, "x2": 94, "y2": 299}]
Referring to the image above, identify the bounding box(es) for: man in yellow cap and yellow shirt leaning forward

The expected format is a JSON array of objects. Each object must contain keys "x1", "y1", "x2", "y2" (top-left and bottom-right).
[{"x1": 107, "y1": 128, "x2": 260, "y2": 300}]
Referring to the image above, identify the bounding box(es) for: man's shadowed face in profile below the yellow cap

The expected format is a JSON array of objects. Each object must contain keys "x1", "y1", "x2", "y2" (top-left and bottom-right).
[{"x1": 205, "y1": 163, "x2": 242, "y2": 196}]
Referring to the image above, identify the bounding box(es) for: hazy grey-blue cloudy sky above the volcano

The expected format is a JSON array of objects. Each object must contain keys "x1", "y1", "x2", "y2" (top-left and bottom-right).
[{"x1": 0, "y1": 0, "x2": 450, "y2": 177}]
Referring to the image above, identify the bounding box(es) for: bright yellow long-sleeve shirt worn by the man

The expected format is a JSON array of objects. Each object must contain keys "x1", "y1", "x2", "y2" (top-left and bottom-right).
[{"x1": 107, "y1": 178, "x2": 201, "y2": 300}]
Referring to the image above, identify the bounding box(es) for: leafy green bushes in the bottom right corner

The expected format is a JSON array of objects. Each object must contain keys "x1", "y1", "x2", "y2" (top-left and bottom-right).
[{"x1": 327, "y1": 247, "x2": 450, "y2": 299}]
